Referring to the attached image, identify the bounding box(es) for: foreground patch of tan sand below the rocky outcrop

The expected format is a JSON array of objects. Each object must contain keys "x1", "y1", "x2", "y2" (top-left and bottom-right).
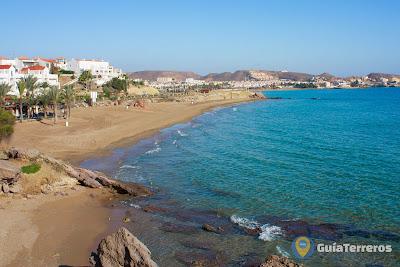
[{"x1": 0, "y1": 187, "x2": 110, "y2": 266}]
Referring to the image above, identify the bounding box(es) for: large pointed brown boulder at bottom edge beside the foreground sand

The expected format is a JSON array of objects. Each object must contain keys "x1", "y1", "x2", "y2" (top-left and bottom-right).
[{"x1": 95, "y1": 227, "x2": 158, "y2": 267}]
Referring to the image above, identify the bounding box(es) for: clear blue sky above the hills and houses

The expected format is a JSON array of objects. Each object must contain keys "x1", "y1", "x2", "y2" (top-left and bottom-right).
[{"x1": 0, "y1": 0, "x2": 400, "y2": 76}]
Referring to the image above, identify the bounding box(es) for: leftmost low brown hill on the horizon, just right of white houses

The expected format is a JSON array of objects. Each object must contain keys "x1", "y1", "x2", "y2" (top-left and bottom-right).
[{"x1": 128, "y1": 71, "x2": 201, "y2": 81}]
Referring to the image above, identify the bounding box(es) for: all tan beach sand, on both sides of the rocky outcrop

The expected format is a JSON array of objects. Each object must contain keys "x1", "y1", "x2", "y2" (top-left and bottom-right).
[{"x1": 0, "y1": 98, "x2": 260, "y2": 266}]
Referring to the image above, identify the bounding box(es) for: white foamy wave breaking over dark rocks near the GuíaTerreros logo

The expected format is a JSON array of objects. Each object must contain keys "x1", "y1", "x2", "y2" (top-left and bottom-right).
[{"x1": 230, "y1": 215, "x2": 282, "y2": 241}]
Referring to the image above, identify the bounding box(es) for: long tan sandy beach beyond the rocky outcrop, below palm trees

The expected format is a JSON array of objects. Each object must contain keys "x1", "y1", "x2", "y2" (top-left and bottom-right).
[{"x1": 9, "y1": 98, "x2": 255, "y2": 163}]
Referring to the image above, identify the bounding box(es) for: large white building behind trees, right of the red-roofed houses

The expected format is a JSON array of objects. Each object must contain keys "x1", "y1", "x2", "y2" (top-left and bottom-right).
[{"x1": 67, "y1": 59, "x2": 123, "y2": 85}]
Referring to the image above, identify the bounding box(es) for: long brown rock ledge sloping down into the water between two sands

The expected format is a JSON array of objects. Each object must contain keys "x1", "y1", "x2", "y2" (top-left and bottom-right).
[{"x1": 0, "y1": 147, "x2": 151, "y2": 196}]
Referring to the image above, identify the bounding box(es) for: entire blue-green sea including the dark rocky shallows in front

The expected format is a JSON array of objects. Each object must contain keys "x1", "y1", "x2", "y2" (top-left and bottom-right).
[{"x1": 81, "y1": 88, "x2": 400, "y2": 266}]
